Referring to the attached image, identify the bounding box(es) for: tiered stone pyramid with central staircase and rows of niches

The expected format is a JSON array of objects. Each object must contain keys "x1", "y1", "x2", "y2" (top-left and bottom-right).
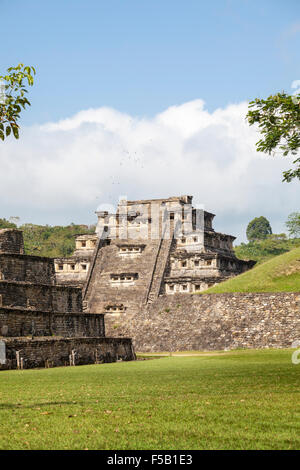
[{"x1": 55, "y1": 196, "x2": 255, "y2": 335}]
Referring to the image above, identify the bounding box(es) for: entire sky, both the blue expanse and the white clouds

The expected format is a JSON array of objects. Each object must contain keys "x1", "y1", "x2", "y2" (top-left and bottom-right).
[{"x1": 0, "y1": 0, "x2": 300, "y2": 241}]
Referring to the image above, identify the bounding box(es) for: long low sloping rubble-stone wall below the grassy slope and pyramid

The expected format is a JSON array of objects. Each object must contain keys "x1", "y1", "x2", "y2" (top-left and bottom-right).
[{"x1": 105, "y1": 292, "x2": 300, "y2": 352}]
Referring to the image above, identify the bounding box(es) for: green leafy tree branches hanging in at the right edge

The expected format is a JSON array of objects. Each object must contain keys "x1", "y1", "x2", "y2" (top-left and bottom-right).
[{"x1": 246, "y1": 92, "x2": 300, "y2": 182}]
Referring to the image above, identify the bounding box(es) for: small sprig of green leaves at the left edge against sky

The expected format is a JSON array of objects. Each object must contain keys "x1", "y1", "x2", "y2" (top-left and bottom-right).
[{"x1": 0, "y1": 64, "x2": 35, "y2": 140}]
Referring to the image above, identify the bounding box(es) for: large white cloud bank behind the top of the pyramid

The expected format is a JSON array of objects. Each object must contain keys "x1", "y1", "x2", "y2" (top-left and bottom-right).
[{"x1": 0, "y1": 100, "x2": 300, "y2": 241}]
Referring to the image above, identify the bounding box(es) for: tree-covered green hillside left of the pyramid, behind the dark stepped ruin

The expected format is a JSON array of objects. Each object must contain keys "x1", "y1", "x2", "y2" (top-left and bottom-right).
[{"x1": 0, "y1": 219, "x2": 95, "y2": 258}]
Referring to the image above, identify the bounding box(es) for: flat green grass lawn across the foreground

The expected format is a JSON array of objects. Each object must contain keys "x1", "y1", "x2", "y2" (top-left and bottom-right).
[{"x1": 0, "y1": 350, "x2": 300, "y2": 450}]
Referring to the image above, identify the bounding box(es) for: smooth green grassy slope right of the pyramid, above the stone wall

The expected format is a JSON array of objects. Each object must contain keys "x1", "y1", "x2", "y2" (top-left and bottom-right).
[{"x1": 202, "y1": 247, "x2": 300, "y2": 294}]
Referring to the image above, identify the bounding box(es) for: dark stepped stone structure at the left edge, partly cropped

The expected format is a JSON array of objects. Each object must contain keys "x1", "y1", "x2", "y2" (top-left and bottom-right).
[{"x1": 0, "y1": 229, "x2": 135, "y2": 370}]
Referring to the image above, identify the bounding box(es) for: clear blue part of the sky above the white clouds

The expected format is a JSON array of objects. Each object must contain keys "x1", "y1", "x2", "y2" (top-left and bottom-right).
[{"x1": 0, "y1": 0, "x2": 300, "y2": 124}]
